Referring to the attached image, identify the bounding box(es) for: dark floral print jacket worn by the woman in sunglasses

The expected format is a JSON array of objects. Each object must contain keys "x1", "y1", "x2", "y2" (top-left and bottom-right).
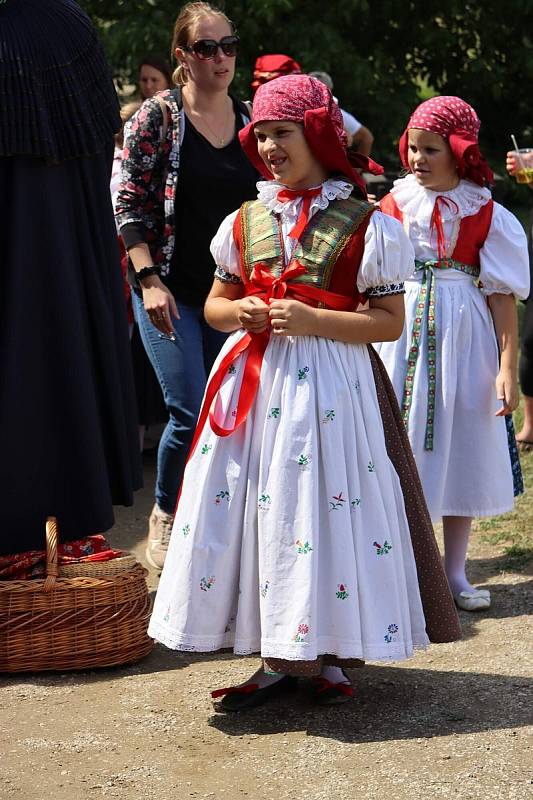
[{"x1": 115, "y1": 87, "x2": 249, "y2": 276}]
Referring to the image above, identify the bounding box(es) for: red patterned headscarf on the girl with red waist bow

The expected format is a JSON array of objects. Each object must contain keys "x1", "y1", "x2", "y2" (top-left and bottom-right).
[{"x1": 239, "y1": 75, "x2": 383, "y2": 197}]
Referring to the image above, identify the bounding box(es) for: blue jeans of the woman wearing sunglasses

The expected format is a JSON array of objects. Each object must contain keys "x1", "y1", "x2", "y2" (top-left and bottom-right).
[{"x1": 133, "y1": 293, "x2": 227, "y2": 514}]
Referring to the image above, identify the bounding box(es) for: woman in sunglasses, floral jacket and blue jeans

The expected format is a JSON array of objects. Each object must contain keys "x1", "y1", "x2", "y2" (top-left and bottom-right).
[{"x1": 115, "y1": 2, "x2": 258, "y2": 569}]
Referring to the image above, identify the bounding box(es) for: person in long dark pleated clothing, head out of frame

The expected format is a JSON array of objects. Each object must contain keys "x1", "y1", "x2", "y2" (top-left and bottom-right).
[{"x1": 0, "y1": 0, "x2": 141, "y2": 554}]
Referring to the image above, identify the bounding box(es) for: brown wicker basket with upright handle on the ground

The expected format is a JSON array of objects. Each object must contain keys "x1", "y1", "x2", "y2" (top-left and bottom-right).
[{"x1": 0, "y1": 518, "x2": 153, "y2": 672}]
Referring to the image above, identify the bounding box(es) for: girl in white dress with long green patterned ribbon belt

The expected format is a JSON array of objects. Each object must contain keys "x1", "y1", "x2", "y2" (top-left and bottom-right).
[{"x1": 378, "y1": 97, "x2": 529, "y2": 611}]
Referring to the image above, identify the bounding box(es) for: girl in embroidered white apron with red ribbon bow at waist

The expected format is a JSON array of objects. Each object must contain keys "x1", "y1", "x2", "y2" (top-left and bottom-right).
[{"x1": 150, "y1": 75, "x2": 459, "y2": 710}]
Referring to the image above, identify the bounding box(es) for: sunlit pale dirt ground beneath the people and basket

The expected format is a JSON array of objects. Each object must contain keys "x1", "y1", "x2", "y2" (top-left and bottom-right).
[{"x1": 0, "y1": 460, "x2": 533, "y2": 800}]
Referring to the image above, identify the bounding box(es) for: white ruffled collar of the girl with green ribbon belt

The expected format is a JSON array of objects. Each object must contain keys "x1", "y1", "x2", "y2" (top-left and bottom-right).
[{"x1": 391, "y1": 174, "x2": 491, "y2": 225}]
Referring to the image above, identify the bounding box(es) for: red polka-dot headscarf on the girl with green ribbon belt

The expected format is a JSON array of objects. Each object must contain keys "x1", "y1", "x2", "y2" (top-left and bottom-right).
[{"x1": 399, "y1": 95, "x2": 494, "y2": 186}]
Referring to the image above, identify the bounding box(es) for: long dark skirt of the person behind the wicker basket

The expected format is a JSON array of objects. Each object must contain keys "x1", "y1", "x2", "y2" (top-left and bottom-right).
[{"x1": 0, "y1": 147, "x2": 141, "y2": 554}]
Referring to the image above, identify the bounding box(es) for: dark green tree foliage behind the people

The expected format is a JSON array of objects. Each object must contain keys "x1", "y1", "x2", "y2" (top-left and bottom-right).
[{"x1": 80, "y1": 0, "x2": 533, "y2": 166}]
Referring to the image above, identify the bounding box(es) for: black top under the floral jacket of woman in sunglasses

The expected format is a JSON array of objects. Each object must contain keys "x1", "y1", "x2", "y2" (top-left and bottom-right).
[{"x1": 164, "y1": 101, "x2": 259, "y2": 306}]
